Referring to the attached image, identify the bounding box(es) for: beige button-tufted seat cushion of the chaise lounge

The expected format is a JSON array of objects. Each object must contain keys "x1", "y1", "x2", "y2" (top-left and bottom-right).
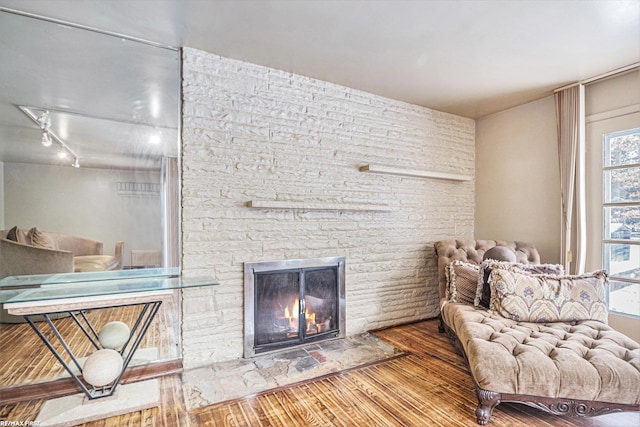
[{"x1": 442, "y1": 303, "x2": 640, "y2": 405}]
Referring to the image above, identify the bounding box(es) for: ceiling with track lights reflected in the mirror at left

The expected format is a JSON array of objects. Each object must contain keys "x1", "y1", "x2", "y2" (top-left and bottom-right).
[{"x1": 0, "y1": 6, "x2": 180, "y2": 169}]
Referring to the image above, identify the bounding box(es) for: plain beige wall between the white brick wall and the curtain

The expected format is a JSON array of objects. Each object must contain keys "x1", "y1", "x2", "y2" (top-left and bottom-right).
[{"x1": 475, "y1": 96, "x2": 560, "y2": 263}]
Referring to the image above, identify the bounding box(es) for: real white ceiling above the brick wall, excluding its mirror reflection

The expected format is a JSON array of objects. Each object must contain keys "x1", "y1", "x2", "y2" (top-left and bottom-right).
[{"x1": 0, "y1": 0, "x2": 640, "y2": 118}]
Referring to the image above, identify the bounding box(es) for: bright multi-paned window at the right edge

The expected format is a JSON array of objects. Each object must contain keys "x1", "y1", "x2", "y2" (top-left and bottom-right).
[{"x1": 602, "y1": 128, "x2": 640, "y2": 316}]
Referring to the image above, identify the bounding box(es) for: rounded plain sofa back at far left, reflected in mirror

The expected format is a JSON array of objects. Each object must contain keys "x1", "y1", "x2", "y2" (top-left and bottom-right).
[{"x1": 0, "y1": 239, "x2": 73, "y2": 278}]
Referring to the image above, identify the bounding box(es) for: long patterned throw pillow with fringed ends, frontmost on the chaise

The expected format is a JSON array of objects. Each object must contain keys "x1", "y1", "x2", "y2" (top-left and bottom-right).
[{"x1": 490, "y1": 268, "x2": 607, "y2": 323}]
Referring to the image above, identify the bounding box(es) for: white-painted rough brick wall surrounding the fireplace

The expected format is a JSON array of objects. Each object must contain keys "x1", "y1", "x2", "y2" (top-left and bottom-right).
[{"x1": 182, "y1": 48, "x2": 475, "y2": 367}]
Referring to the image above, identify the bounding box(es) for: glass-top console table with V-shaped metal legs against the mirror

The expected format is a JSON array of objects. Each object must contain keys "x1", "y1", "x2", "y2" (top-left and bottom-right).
[{"x1": 0, "y1": 268, "x2": 219, "y2": 400}]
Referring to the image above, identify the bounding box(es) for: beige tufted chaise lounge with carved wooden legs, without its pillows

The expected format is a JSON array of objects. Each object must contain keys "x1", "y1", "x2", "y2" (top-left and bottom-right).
[{"x1": 435, "y1": 240, "x2": 640, "y2": 425}]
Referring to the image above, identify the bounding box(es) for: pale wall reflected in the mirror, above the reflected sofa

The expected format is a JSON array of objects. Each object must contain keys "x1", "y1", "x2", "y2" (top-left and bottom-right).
[{"x1": 3, "y1": 163, "x2": 162, "y2": 265}]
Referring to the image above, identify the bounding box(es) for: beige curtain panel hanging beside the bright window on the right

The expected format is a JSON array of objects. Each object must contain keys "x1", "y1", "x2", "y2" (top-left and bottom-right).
[{"x1": 555, "y1": 84, "x2": 587, "y2": 274}]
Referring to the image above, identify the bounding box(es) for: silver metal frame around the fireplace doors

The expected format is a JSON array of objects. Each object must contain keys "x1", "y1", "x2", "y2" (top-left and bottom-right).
[{"x1": 244, "y1": 257, "x2": 346, "y2": 358}]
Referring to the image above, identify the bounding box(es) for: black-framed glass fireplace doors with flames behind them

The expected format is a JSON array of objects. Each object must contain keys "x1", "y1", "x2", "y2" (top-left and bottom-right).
[{"x1": 254, "y1": 266, "x2": 340, "y2": 353}]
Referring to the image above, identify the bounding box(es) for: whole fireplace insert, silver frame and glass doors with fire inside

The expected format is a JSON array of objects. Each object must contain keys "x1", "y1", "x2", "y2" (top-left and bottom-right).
[{"x1": 244, "y1": 257, "x2": 346, "y2": 357}]
